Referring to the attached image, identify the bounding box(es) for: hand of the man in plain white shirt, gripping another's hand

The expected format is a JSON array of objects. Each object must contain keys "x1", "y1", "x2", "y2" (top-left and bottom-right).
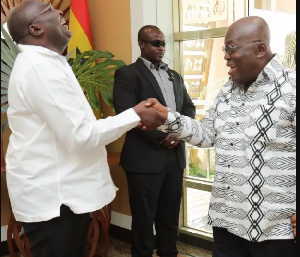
[{"x1": 133, "y1": 101, "x2": 166, "y2": 130}]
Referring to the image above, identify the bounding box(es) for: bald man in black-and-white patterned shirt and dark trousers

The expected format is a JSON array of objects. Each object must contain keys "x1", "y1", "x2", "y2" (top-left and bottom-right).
[{"x1": 148, "y1": 17, "x2": 296, "y2": 257}]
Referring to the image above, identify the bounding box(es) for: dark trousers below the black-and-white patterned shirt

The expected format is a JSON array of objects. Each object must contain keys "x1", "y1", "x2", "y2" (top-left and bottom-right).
[{"x1": 212, "y1": 227, "x2": 296, "y2": 257}]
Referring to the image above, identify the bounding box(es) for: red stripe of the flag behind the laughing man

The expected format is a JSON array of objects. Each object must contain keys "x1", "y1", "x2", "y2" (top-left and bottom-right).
[{"x1": 70, "y1": 0, "x2": 93, "y2": 46}]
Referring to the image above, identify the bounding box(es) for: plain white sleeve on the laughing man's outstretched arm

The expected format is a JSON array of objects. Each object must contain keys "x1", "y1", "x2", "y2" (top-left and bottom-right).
[{"x1": 20, "y1": 65, "x2": 140, "y2": 152}]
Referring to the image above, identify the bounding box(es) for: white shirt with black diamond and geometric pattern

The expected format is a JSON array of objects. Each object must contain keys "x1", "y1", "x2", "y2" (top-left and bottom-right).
[{"x1": 160, "y1": 55, "x2": 296, "y2": 242}]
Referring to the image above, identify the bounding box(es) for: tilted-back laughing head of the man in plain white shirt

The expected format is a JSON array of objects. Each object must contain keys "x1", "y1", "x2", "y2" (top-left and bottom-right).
[{"x1": 7, "y1": 0, "x2": 72, "y2": 54}]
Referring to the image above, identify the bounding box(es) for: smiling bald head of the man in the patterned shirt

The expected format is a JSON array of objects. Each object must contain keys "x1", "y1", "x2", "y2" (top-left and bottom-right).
[{"x1": 224, "y1": 16, "x2": 274, "y2": 92}]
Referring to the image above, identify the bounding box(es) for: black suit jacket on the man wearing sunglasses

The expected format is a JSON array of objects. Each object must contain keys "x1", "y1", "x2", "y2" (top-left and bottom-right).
[{"x1": 113, "y1": 58, "x2": 195, "y2": 173}]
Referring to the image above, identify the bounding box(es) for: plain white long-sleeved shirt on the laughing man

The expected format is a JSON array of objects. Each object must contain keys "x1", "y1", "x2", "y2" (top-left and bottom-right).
[{"x1": 6, "y1": 45, "x2": 140, "y2": 222}]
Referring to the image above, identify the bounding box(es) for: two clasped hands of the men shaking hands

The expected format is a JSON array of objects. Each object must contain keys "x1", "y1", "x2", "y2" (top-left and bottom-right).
[{"x1": 133, "y1": 98, "x2": 168, "y2": 130}]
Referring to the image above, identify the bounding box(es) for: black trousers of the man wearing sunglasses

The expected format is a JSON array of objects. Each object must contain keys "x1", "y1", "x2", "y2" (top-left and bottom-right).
[{"x1": 126, "y1": 150, "x2": 183, "y2": 257}]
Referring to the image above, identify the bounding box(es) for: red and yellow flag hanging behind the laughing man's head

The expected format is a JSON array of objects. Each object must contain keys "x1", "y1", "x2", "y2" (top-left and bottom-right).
[{"x1": 68, "y1": 0, "x2": 93, "y2": 57}]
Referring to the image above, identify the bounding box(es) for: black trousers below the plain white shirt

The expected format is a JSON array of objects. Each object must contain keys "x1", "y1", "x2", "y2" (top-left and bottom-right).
[{"x1": 23, "y1": 205, "x2": 90, "y2": 257}]
